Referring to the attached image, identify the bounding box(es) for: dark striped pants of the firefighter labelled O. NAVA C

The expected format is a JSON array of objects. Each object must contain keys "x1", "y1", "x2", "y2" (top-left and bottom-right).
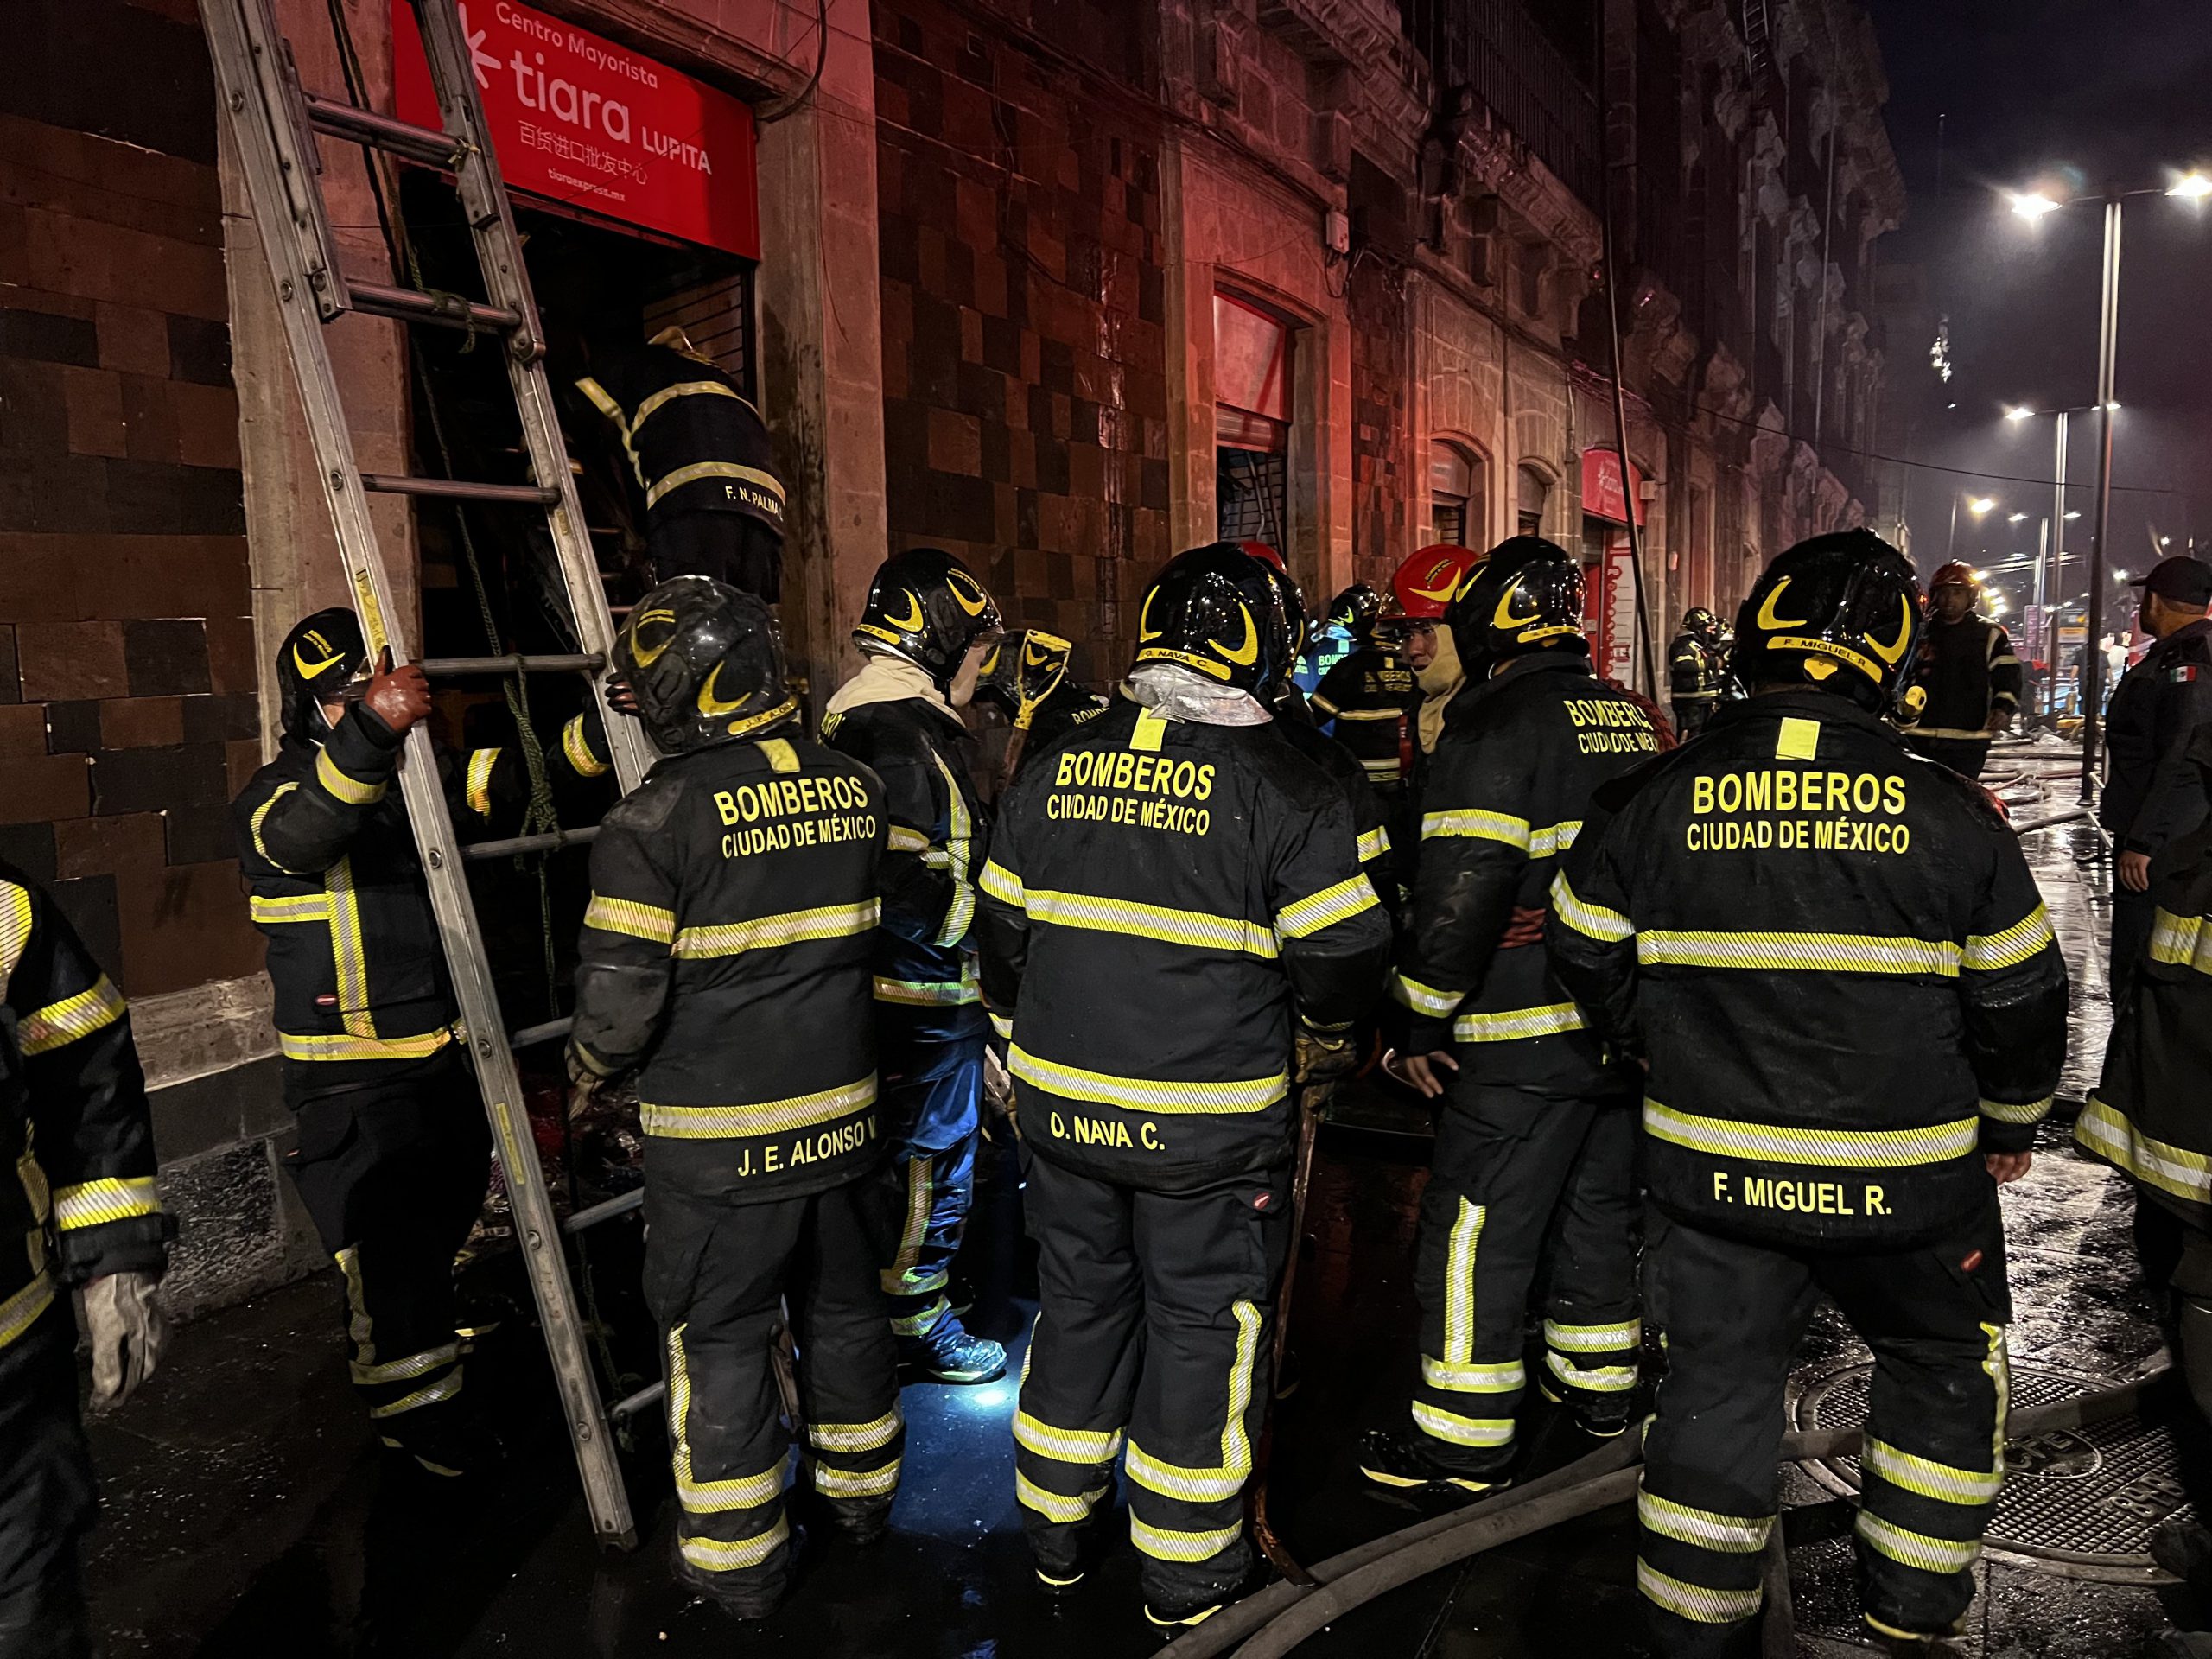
[{"x1": 1013, "y1": 1150, "x2": 1292, "y2": 1612}]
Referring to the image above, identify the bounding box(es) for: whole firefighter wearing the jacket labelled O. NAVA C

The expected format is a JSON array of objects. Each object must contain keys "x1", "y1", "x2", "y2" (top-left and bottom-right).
[{"x1": 980, "y1": 542, "x2": 1389, "y2": 1628}]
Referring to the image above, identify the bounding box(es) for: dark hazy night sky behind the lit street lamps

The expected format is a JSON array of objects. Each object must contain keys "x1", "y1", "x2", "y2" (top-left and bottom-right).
[{"x1": 1867, "y1": 0, "x2": 2212, "y2": 606}]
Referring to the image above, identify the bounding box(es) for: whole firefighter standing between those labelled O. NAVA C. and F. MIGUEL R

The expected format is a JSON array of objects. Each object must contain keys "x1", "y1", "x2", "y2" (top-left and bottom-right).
[{"x1": 1360, "y1": 536, "x2": 1659, "y2": 1497}]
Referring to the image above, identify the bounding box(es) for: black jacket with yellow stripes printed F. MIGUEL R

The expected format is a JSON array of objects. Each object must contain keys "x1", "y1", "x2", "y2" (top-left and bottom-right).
[{"x1": 1546, "y1": 688, "x2": 2066, "y2": 1248}]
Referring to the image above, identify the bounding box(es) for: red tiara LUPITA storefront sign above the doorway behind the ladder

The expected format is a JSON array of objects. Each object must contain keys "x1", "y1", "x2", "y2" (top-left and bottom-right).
[{"x1": 391, "y1": 0, "x2": 761, "y2": 259}]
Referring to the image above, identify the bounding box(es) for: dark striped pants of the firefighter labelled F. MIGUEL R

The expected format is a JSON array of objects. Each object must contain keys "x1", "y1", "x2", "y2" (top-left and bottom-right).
[{"x1": 1637, "y1": 1192, "x2": 2011, "y2": 1659}]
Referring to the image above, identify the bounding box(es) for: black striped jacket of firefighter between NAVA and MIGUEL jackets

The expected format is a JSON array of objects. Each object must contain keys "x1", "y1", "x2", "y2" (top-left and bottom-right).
[{"x1": 1391, "y1": 652, "x2": 1659, "y2": 1097}]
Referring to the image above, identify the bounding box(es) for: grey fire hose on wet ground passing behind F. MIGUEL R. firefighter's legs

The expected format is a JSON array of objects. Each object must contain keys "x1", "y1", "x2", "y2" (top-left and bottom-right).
[{"x1": 1161, "y1": 1365, "x2": 2172, "y2": 1659}]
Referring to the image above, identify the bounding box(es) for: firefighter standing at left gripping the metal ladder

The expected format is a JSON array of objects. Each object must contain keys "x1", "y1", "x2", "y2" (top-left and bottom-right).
[{"x1": 232, "y1": 611, "x2": 608, "y2": 1476}]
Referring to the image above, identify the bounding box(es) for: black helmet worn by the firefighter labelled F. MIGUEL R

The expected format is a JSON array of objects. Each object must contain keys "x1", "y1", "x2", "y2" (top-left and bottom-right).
[{"x1": 1727, "y1": 529, "x2": 1923, "y2": 715}]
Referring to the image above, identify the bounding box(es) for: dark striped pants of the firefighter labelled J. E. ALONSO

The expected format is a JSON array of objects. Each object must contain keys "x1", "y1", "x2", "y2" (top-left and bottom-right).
[{"x1": 646, "y1": 1176, "x2": 907, "y2": 1611}]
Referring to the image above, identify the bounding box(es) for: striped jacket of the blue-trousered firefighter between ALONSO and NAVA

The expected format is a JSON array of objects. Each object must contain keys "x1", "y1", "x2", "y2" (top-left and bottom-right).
[{"x1": 823, "y1": 696, "x2": 991, "y2": 1039}]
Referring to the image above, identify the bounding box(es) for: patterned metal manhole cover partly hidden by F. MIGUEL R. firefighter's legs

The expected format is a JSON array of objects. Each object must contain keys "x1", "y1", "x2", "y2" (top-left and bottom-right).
[{"x1": 1792, "y1": 1363, "x2": 2188, "y2": 1580}]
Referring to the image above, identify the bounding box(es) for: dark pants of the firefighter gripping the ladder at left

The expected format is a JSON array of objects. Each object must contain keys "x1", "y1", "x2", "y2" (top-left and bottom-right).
[{"x1": 285, "y1": 1048, "x2": 491, "y2": 1445}]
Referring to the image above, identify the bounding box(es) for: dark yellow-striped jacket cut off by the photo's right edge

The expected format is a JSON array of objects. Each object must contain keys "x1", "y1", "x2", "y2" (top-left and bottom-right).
[{"x1": 2075, "y1": 726, "x2": 2212, "y2": 1230}]
